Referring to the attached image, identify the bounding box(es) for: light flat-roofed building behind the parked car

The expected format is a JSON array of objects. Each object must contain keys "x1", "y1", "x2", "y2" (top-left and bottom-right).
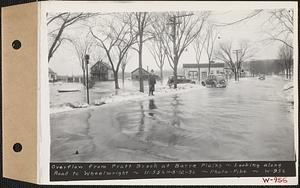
[{"x1": 183, "y1": 63, "x2": 226, "y2": 80}]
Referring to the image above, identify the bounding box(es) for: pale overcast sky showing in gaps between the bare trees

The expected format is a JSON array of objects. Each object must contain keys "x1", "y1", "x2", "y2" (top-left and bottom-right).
[{"x1": 49, "y1": 10, "x2": 290, "y2": 76}]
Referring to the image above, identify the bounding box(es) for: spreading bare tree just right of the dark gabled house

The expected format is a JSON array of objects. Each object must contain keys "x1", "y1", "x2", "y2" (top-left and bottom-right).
[{"x1": 90, "y1": 13, "x2": 136, "y2": 89}]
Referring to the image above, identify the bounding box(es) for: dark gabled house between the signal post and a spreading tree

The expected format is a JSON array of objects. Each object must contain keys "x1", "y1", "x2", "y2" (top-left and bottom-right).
[{"x1": 90, "y1": 61, "x2": 114, "y2": 81}]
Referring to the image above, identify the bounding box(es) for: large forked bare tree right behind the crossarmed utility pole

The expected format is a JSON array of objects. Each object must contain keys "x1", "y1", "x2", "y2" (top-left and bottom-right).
[{"x1": 156, "y1": 12, "x2": 209, "y2": 88}]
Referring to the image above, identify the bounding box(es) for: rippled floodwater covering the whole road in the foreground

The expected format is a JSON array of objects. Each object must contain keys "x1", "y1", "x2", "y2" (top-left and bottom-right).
[{"x1": 51, "y1": 77, "x2": 295, "y2": 162}]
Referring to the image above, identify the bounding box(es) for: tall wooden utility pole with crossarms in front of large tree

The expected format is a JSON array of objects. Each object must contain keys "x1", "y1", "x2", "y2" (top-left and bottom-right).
[{"x1": 167, "y1": 14, "x2": 194, "y2": 88}]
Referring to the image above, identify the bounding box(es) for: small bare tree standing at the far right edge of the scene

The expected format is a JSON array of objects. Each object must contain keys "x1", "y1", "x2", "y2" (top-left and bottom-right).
[{"x1": 278, "y1": 44, "x2": 293, "y2": 79}]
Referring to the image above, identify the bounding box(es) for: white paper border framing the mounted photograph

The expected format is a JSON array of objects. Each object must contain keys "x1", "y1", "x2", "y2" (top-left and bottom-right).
[{"x1": 37, "y1": 1, "x2": 299, "y2": 185}]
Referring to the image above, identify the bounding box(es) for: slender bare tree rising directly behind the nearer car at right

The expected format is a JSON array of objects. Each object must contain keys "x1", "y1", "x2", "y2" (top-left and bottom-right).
[{"x1": 204, "y1": 25, "x2": 218, "y2": 75}]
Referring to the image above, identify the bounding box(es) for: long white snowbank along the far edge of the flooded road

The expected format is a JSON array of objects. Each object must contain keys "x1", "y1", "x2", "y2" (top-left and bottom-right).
[{"x1": 50, "y1": 84, "x2": 203, "y2": 114}]
